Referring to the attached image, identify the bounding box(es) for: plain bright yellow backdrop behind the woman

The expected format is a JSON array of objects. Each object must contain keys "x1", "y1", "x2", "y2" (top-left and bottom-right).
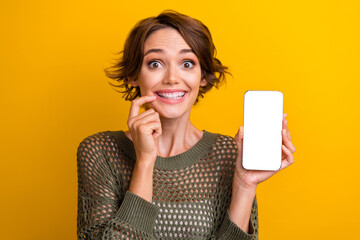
[{"x1": 0, "y1": 0, "x2": 360, "y2": 240}]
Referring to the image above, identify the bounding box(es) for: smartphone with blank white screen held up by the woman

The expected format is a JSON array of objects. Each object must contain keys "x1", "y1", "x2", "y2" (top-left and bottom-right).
[{"x1": 242, "y1": 90, "x2": 284, "y2": 171}]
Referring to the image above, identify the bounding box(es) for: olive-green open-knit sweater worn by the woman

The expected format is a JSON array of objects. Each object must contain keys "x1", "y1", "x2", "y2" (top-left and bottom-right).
[{"x1": 77, "y1": 130, "x2": 258, "y2": 240}]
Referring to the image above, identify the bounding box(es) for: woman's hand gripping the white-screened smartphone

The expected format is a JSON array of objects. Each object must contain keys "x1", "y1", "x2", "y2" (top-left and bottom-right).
[{"x1": 233, "y1": 113, "x2": 295, "y2": 190}]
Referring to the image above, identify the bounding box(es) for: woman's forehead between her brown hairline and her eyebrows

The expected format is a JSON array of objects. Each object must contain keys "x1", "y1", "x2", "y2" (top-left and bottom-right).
[{"x1": 144, "y1": 28, "x2": 190, "y2": 52}]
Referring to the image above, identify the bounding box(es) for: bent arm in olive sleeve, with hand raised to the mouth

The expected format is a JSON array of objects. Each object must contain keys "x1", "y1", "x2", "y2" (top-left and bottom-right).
[{"x1": 78, "y1": 96, "x2": 161, "y2": 240}]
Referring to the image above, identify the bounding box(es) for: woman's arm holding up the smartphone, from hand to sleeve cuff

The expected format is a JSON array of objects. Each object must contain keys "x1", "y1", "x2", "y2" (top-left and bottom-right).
[{"x1": 217, "y1": 113, "x2": 295, "y2": 239}]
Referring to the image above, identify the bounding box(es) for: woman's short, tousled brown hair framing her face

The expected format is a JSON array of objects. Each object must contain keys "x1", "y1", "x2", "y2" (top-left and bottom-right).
[{"x1": 105, "y1": 10, "x2": 230, "y2": 105}]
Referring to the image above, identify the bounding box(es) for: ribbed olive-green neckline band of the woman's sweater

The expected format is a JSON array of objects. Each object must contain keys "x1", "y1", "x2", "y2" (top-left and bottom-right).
[{"x1": 109, "y1": 129, "x2": 218, "y2": 170}]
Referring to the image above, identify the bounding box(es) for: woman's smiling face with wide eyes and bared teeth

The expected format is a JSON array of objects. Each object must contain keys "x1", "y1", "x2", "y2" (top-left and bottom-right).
[{"x1": 130, "y1": 28, "x2": 206, "y2": 118}]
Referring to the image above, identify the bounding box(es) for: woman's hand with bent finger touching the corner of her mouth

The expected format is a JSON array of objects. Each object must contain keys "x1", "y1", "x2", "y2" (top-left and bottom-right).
[{"x1": 127, "y1": 96, "x2": 162, "y2": 162}]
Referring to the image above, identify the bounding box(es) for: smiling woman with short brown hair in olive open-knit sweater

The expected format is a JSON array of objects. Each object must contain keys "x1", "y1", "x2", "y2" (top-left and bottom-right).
[{"x1": 78, "y1": 11, "x2": 295, "y2": 239}]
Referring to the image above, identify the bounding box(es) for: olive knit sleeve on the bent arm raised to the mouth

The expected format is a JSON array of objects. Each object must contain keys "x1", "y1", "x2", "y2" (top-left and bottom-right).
[{"x1": 77, "y1": 134, "x2": 159, "y2": 240}]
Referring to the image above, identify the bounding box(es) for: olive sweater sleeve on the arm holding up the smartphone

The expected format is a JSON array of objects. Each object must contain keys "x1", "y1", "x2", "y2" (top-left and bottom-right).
[{"x1": 216, "y1": 196, "x2": 259, "y2": 240}]
